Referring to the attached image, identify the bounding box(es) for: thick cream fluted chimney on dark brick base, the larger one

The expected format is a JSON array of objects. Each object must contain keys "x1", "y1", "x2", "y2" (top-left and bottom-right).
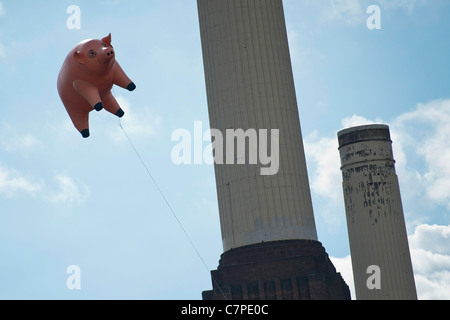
[{"x1": 198, "y1": 0, "x2": 349, "y2": 299}]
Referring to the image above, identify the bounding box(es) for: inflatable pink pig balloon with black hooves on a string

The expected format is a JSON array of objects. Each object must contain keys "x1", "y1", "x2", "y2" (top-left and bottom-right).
[{"x1": 58, "y1": 34, "x2": 136, "y2": 138}]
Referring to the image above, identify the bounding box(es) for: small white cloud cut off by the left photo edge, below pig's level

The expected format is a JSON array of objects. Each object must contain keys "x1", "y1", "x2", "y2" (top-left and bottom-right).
[{"x1": 0, "y1": 164, "x2": 41, "y2": 197}]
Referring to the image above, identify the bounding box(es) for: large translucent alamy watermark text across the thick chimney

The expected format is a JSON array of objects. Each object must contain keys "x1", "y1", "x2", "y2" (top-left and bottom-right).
[{"x1": 171, "y1": 121, "x2": 280, "y2": 176}]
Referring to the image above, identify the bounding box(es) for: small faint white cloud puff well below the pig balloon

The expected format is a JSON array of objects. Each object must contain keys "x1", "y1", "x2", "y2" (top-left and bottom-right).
[{"x1": 48, "y1": 175, "x2": 90, "y2": 205}]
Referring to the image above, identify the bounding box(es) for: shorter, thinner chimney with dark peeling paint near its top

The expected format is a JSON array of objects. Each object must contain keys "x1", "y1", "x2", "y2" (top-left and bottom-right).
[{"x1": 338, "y1": 125, "x2": 417, "y2": 300}]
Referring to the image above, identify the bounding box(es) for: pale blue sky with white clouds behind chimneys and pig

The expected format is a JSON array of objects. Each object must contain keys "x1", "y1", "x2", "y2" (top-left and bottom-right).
[{"x1": 0, "y1": 0, "x2": 450, "y2": 299}]
